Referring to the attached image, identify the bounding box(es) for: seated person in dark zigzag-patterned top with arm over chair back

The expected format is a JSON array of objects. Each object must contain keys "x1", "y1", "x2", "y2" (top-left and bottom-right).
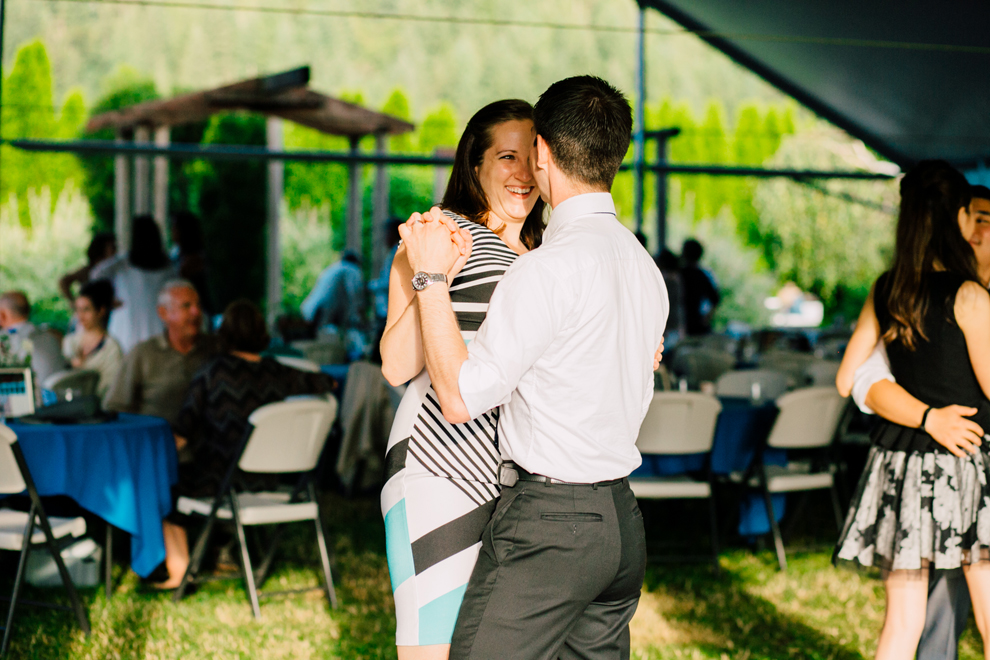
[{"x1": 160, "y1": 300, "x2": 334, "y2": 589}]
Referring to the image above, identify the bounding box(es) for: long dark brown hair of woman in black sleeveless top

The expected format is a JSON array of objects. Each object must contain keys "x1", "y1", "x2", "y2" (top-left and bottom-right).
[{"x1": 888, "y1": 160, "x2": 980, "y2": 350}]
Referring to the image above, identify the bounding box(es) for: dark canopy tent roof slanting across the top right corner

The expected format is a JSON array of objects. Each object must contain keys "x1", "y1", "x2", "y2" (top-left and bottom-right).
[{"x1": 639, "y1": 0, "x2": 990, "y2": 175}]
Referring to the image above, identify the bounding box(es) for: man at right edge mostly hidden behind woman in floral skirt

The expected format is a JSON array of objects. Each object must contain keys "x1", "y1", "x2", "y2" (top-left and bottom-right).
[{"x1": 852, "y1": 186, "x2": 990, "y2": 660}]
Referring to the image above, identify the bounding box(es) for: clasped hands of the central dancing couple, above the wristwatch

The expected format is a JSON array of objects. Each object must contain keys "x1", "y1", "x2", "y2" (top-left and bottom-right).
[{"x1": 399, "y1": 206, "x2": 472, "y2": 285}]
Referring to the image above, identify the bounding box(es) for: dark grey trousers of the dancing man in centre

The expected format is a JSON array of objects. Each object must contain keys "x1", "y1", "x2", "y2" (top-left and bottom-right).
[{"x1": 450, "y1": 479, "x2": 646, "y2": 660}]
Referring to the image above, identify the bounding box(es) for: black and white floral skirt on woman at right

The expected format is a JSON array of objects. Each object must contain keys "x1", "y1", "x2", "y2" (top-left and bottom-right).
[{"x1": 833, "y1": 446, "x2": 990, "y2": 571}]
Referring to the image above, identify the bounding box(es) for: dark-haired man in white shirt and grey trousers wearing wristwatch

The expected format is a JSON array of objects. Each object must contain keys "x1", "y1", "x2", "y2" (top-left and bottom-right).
[{"x1": 401, "y1": 76, "x2": 668, "y2": 659}]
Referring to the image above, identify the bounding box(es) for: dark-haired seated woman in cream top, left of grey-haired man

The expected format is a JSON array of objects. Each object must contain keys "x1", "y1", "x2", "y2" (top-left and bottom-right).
[{"x1": 62, "y1": 280, "x2": 124, "y2": 398}]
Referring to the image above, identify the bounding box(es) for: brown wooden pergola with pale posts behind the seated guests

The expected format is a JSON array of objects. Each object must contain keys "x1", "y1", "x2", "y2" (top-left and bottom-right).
[{"x1": 86, "y1": 67, "x2": 415, "y2": 316}]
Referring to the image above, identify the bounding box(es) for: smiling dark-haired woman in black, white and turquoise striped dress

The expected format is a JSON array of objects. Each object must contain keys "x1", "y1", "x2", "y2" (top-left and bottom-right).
[{"x1": 381, "y1": 100, "x2": 544, "y2": 660}]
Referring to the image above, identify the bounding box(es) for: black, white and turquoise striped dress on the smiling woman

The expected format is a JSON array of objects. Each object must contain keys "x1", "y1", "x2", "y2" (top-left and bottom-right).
[{"x1": 382, "y1": 211, "x2": 517, "y2": 646}]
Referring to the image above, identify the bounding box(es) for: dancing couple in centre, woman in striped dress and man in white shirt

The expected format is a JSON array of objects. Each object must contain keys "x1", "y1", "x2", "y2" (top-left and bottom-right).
[{"x1": 381, "y1": 76, "x2": 668, "y2": 660}]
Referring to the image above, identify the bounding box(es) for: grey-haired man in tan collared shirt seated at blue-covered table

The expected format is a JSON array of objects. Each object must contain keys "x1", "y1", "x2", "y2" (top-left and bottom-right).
[{"x1": 104, "y1": 280, "x2": 216, "y2": 424}]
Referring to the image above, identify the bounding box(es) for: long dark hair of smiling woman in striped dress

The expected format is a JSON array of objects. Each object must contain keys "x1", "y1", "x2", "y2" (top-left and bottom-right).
[{"x1": 440, "y1": 99, "x2": 546, "y2": 250}]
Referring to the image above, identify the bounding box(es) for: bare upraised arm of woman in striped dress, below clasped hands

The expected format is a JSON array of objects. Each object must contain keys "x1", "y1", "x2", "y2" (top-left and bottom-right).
[{"x1": 381, "y1": 245, "x2": 426, "y2": 385}]
